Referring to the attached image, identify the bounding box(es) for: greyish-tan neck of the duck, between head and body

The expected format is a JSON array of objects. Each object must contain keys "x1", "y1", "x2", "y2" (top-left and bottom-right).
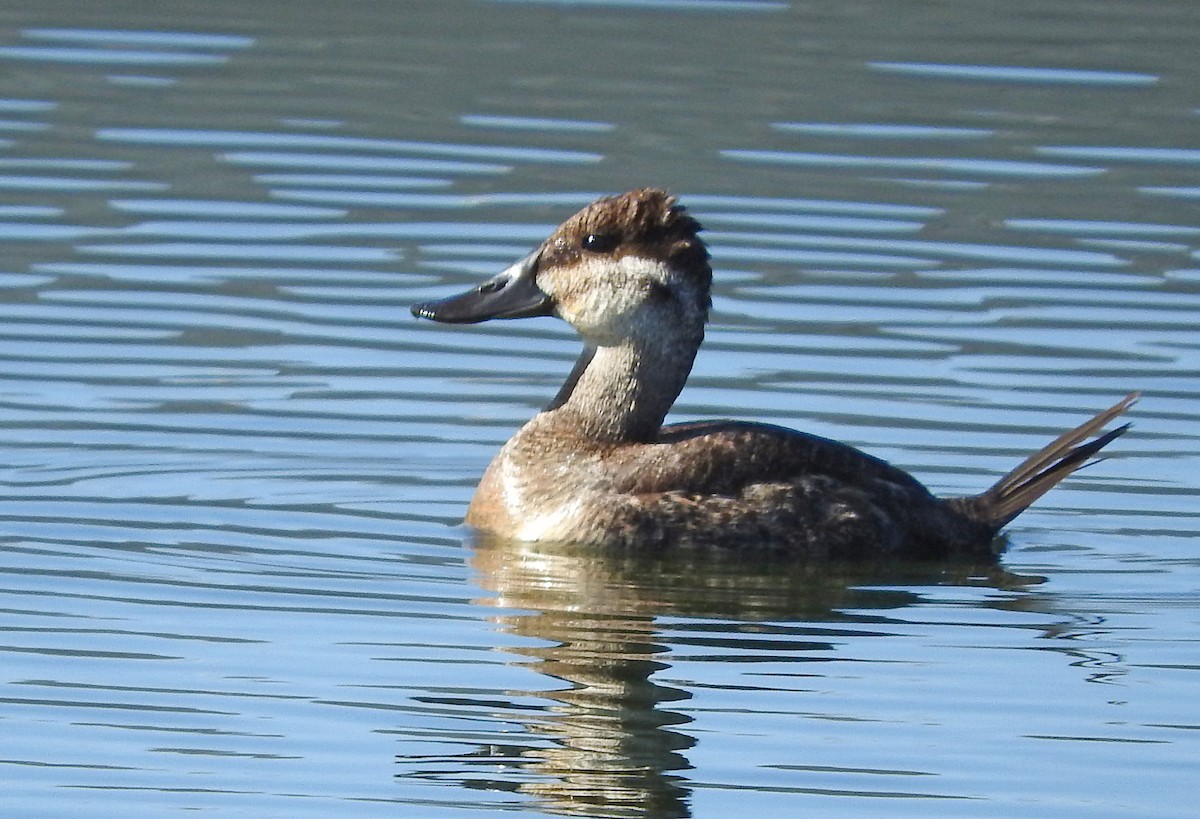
[{"x1": 541, "y1": 331, "x2": 703, "y2": 443}]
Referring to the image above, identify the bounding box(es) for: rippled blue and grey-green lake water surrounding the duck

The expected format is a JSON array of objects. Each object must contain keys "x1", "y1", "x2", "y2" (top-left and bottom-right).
[{"x1": 0, "y1": 0, "x2": 1200, "y2": 819}]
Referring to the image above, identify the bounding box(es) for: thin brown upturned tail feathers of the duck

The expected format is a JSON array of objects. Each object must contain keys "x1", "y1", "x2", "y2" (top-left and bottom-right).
[{"x1": 952, "y1": 393, "x2": 1139, "y2": 532}]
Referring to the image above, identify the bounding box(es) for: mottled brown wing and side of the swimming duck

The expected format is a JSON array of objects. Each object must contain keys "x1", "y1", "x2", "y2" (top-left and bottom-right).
[{"x1": 583, "y1": 422, "x2": 969, "y2": 560}]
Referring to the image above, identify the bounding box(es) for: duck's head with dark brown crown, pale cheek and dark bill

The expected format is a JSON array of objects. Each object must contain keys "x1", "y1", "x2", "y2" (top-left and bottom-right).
[{"x1": 413, "y1": 189, "x2": 713, "y2": 346}]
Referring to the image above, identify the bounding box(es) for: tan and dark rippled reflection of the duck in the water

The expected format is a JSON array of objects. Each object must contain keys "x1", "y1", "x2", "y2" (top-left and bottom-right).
[{"x1": 434, "y1": 539, "x2": 1037, "y2": 817}]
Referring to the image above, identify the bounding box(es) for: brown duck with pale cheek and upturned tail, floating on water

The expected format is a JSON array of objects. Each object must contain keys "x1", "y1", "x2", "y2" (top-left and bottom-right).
[{"x1": 412, "y1": 187, "x2": 1138, "y2": 561}]
